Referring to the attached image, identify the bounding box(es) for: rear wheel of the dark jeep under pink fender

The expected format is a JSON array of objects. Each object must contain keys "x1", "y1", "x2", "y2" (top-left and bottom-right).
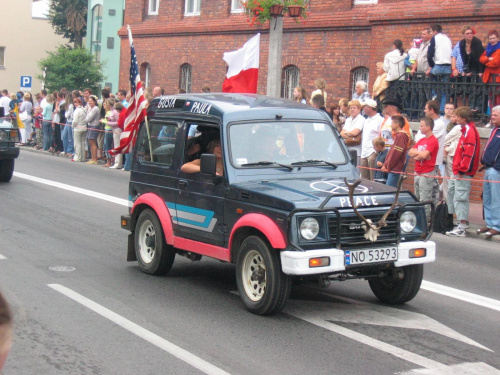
[{"x1": 134, "y1": 209, "x2": 175, "y2": 275}]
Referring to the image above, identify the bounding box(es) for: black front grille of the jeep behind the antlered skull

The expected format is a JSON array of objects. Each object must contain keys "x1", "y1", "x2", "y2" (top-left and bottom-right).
[{"x1": 328, "y1": 208, "x2": 399, "y2": 248}]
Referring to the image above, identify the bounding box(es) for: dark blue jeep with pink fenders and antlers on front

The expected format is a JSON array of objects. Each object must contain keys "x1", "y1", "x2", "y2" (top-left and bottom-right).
[{"x1": 122, "y1": 94, "x2": 435, "y2": 314}]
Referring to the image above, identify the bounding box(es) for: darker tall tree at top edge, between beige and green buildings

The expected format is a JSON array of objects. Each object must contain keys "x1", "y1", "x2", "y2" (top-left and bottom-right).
[{"x1": 49, "y1": 0, "x2": 88, "y2": 48}]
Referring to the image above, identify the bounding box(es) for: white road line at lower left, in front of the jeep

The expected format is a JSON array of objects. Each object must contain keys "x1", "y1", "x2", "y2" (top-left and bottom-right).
[{"x1": 48, "y1": 284, "x2": 229, "y2": 375}]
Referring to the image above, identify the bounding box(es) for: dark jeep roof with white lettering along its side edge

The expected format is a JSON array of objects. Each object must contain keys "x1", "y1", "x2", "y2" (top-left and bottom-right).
[{"x1": 148, "y1": 93, "x2": 325, "y2": 120}]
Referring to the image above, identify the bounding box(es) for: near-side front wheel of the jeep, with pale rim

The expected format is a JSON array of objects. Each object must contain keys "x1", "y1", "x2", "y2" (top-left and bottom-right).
[{"x1": 236, "y1": 236, "x2": 292, "y2": 315}]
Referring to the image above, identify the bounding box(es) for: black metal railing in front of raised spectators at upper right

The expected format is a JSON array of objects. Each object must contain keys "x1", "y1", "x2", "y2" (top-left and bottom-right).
[{"x1": 386, "y1": 73, "x2": 500, "y2": 125}]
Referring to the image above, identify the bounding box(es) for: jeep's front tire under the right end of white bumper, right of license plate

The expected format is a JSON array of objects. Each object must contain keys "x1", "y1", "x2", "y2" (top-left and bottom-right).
[{"x1": 369, "y1": 264, "x2": 424, "y2": 305}]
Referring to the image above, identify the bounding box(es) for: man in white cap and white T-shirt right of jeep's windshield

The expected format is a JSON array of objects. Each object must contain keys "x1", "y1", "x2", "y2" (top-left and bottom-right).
[{"x1": 360, "y1": 99, "x2": 383, "y2": 181}]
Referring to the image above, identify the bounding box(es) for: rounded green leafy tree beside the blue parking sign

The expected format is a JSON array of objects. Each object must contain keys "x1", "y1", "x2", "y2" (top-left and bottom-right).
[{"x1": 37, "y1": 46, "x2": 105, "y2": 92}]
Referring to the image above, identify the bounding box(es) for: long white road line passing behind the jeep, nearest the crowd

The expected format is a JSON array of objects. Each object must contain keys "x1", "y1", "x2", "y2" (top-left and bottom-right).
[{"x1": 14, "y1": 172, "x2": 500, "y2": 311}]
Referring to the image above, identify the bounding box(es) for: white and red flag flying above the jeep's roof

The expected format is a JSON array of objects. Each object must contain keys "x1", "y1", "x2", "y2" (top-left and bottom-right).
[{"x1": 222, "y1": 34, "x2": 260, "y2": 94}]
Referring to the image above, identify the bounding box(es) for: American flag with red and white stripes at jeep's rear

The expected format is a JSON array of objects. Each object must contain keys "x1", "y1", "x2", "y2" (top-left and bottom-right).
[{"x1": 110, "y1": 27, "x2": 148, "y2": 155}]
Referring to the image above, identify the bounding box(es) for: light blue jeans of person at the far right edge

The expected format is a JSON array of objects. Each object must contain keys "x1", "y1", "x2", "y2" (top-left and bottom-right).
[{"x1": 483, "y1": 167, "x2": 500, "y2": 231}]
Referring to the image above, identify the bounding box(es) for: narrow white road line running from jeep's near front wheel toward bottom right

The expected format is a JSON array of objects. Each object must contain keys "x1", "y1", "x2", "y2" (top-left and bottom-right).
[{"x1": 283, "y1": 300, "x2": 445, "y2": 369}]
